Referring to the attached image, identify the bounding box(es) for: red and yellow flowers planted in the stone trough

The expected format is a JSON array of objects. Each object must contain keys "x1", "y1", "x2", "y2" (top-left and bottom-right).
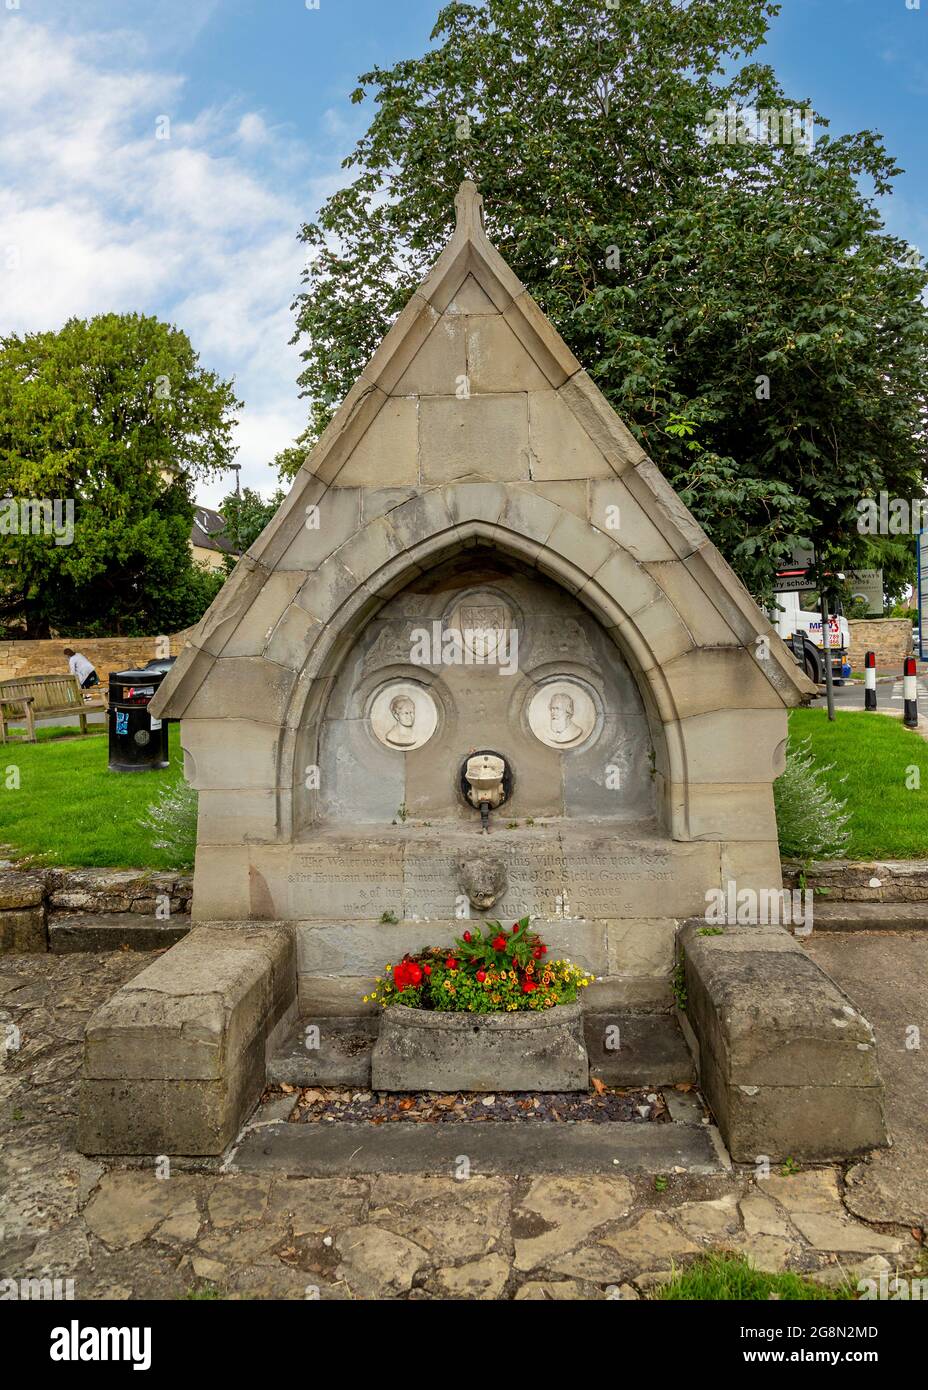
[{"x1": 364, "y1": 917, "x2": 593, "y2": 1013}]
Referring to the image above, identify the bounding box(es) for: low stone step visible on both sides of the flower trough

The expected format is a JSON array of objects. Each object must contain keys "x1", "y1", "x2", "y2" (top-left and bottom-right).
[{"x1": 268, "y1": 1012, "x2": 696, "y2": 1088}]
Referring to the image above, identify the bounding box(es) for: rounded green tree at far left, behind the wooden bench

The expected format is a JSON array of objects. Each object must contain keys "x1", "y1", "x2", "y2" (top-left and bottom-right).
[{"x1": 0, "y1": 314, "x2": 240, "y2": 637}]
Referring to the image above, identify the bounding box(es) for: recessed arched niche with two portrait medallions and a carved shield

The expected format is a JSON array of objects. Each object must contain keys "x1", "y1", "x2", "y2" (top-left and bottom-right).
[{"x1": 315, "y1": 548, "x2": 657, "y2": 830}]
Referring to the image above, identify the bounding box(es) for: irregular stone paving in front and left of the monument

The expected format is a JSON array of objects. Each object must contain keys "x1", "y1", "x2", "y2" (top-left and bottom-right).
[{"x1": 0, "y1": 954, "x2": 928, "y2": 1300}]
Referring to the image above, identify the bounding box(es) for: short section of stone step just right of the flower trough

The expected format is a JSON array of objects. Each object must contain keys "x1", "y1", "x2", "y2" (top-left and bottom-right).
[{"x1": 583, "y1": 1012, "x2": 696, "y2": 1086}]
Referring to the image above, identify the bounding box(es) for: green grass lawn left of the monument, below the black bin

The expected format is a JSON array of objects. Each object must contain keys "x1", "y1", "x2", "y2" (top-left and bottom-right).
[{"x1": 0, "y1": 724, "x2": 183, "y2": 869}]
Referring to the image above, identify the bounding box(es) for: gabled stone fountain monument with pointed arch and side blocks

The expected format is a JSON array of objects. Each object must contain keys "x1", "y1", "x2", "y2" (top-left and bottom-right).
[{"x1": 81, "y1": 183, "x2": 882, "y2": 1154}]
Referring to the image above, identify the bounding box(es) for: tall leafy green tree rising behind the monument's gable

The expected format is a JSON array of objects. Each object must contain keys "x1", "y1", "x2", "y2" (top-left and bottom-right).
[{"x1": 278, "y1": 0, "x2": 928, "y2": 598}]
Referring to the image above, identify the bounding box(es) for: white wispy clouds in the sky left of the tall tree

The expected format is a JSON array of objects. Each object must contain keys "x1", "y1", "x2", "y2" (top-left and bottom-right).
[{"x1": 0, "y1": 12, "x2": 351, "y2": 503}]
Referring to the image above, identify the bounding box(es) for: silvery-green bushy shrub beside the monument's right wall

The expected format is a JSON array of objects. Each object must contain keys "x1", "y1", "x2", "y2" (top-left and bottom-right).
[{"x1": 774, "y1": 738, "x2": 850, "y2": 860}]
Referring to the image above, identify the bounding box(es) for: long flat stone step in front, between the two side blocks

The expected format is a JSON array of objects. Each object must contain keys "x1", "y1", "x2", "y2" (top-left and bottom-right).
[{"x1": 229, "y1": 1111, "x2": 729, "y2": 1177}]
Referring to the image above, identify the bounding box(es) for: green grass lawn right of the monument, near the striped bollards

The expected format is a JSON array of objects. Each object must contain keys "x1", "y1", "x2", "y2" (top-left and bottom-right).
[{"x1": 789, "y1": 709, "x2": 928, "y2": 859}]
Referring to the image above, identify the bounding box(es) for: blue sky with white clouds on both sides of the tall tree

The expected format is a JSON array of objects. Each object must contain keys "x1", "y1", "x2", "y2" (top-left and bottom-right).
[{"x1": 0, "y1": 0, "x2": 928, "y2": 503}]
